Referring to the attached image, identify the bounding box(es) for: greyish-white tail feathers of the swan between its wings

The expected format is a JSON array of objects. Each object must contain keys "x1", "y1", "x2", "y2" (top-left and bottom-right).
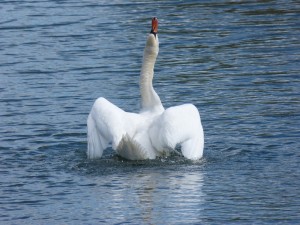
[{"x1": 117, "y1": 134, "x2": 149, "y2": 160}]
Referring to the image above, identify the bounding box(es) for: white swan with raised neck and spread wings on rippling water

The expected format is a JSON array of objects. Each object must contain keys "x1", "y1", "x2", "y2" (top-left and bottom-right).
[{"x1": 87, "y1": 17, "x2": 204, "y2": 160}]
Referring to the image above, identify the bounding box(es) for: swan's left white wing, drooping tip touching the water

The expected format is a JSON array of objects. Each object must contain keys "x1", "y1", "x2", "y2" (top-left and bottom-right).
[{"x1": 87, "y1": 98, "x2": 126, "y2": 159}]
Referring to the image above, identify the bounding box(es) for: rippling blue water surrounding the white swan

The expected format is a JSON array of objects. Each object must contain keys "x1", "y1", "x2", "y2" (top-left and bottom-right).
[{"x1": 0, "y1": 0, "x2": 300, "y2": 224}]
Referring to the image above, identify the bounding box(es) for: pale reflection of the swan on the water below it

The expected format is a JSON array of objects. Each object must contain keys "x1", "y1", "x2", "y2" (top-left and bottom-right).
[{"x1": 88, "y1": 165, "x2": 204, "y2": 224}]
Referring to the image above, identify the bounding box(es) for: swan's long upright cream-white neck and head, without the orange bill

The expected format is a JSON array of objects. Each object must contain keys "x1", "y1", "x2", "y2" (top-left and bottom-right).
[{"x1": 140, "y1": 34, "x2": 164, "y2": 111}]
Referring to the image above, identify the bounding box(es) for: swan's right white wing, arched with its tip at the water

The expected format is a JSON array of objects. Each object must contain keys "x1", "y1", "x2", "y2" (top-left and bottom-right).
[{"x1": 149, "y1": 104, "x2": 204, "y2": 160}]
